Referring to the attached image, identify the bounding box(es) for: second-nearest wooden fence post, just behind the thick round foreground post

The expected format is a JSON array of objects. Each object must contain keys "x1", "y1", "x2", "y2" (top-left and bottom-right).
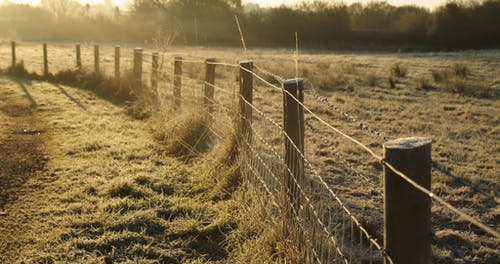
[{"x1": 283, "y1": 79, "x2": 305, "y2": 235}]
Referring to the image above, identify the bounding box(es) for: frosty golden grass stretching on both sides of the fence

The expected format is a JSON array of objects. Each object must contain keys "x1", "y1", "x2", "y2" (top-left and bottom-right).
[{"x1": 0, "y1": 43, "x2": 500, "y2": 263}]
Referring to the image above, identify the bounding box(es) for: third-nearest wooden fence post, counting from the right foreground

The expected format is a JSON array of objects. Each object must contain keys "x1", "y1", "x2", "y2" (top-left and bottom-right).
[{"x1": 238, "y1": 61, "x2": 253, "y2": 143}]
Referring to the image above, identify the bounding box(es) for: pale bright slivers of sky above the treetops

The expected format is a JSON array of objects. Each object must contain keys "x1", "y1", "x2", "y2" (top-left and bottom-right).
[{"x1": 0, "y1": 0, "x2": 446, "y2": 8}]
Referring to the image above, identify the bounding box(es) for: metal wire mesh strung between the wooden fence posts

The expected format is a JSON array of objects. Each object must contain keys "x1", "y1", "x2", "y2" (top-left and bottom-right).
[{"x1": 0, "y1": 43, "x2": 495, "y2": 263}]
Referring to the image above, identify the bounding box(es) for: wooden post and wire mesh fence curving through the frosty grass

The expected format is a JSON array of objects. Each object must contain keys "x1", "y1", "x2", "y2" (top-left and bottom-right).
[{"x1": 1, "y1": 42, "x2": 500, "y2": 263}]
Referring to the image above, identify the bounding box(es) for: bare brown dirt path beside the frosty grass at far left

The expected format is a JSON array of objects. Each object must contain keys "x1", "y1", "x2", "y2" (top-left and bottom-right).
[{"x1": 0, "y1": 79, "x2": 52, "y2": 262}]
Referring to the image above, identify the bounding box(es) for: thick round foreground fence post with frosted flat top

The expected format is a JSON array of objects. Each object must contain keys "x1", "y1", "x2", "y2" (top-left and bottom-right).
[{"x1": 384, "y1": 138, "x2": 432, "y2": 264}]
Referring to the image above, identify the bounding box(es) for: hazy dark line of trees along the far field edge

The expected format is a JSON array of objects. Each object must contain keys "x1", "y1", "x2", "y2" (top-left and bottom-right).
[{"x1": 0, "y1": 0, "x2": 500, "y2": 49}]
